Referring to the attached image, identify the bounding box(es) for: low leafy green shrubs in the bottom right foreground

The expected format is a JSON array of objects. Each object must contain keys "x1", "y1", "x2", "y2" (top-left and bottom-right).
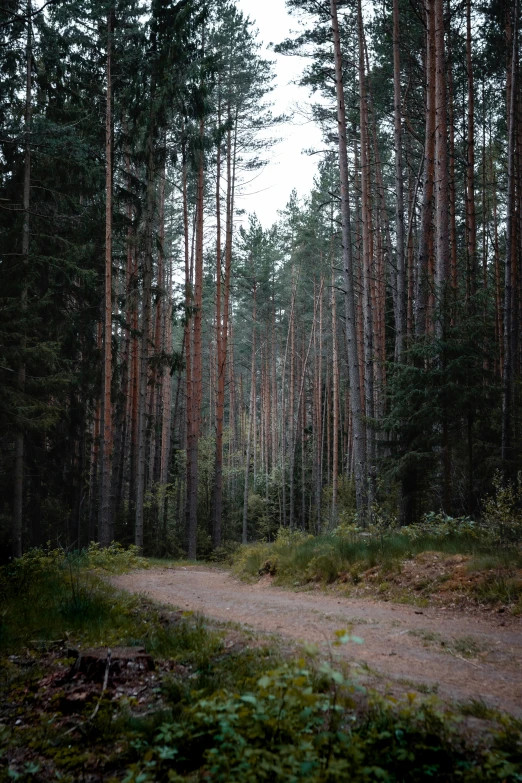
[{"x1": 124, "y1": 661, "x2": 522, "y2": 783}]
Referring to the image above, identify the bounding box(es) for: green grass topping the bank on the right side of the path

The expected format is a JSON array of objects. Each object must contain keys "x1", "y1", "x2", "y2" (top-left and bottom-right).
[{"x1": 233, "y1": 525, "x2": 522, "y2": 610}]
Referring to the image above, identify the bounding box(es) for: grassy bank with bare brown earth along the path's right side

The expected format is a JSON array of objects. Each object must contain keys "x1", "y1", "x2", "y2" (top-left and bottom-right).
[{"x1": 233, "y1": 515, "x2": 522, "y2": 612}]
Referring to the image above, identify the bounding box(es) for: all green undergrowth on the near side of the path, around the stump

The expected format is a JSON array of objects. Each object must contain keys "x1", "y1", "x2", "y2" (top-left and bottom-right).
[{"x1": 0, "y1": 552, "x2": 522, "y2": 783}]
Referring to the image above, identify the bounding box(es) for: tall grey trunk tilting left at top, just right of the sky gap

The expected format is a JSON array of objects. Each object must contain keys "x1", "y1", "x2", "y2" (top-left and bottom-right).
[{"x1": 330, "y1": 0, "x2": 367, "y2": 514}]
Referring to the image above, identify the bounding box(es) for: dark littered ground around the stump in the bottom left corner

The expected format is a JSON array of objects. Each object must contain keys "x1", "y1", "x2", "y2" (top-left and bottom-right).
[{"x1": 0, "y1": 642, "x2": 173, "y2": 783}]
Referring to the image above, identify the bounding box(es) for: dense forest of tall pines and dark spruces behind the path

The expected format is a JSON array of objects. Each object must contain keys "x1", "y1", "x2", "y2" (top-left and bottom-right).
[{"x1": 0, "y1": 0, "x2": 522, "y2": 559}]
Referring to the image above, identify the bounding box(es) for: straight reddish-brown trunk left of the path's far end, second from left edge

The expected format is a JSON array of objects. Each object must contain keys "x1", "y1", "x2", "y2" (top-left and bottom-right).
[{"x1": 98, "y1": 9, "x2": 114, "y2": 547}]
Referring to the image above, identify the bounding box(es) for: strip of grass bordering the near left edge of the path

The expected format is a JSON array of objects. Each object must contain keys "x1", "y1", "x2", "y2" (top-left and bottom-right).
[{"x1": 0, "y1": 550, "x2": 278, "y2": 692}]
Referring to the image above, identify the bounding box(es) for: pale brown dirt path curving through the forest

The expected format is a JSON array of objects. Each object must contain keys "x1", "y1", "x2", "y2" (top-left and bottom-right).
[{"x1": 111, "y1": 566, "x2": 522, "y2": 716}]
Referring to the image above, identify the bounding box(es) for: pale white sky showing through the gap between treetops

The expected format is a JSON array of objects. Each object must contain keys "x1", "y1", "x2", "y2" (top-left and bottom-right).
[{"x1": 233, "y1": 0, "x2": 322, "y2": 228}]
